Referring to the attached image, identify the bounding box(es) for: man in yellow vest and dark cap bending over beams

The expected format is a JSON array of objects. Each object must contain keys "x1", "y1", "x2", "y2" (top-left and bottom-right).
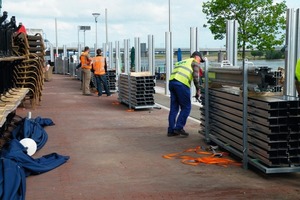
[{"x1": 167, "y1": 51, "x2": 205, "y2": 137}]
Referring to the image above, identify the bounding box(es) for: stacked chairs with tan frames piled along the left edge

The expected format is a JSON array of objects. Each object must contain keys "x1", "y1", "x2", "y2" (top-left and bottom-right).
[{"x1": 0, "y1": 12, "x2": 45, "y2": 150}]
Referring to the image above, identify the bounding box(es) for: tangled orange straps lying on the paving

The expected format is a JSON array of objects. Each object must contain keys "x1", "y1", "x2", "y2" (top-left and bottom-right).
[{"x1": 162, "y1": 146, "x2": 241, "y2": 167}]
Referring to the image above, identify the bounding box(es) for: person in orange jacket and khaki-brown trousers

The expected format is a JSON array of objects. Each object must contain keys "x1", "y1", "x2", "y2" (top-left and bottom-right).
[{"x1": 80, "y1": 47, "x2": 92, "y2": 96}]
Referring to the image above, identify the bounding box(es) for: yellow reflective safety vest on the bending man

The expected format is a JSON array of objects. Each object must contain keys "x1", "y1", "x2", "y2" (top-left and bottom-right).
[{"x1": 170, "y1": 58, "x2": 194, "y2": 87}]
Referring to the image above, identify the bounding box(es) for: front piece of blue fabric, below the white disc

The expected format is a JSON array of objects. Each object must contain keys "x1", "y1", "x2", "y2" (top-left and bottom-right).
[{"x1": 0, "y1": 139, "x2": 69, "y2": 200}]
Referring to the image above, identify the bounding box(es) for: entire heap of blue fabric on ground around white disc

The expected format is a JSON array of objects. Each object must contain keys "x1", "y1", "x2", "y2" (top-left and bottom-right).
[{"x1": 0, "y1": 117, "x2": 70, "y2": 200}]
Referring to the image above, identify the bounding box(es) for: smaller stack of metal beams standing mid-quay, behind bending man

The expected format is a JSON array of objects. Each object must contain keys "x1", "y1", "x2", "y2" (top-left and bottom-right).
[{"x1": 119, "y1": 72, "x2": 155, "y2": 109}]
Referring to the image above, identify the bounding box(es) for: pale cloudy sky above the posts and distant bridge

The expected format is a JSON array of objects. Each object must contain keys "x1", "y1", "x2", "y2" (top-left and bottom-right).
[{"x1": 0, "y1": 0, "x2": 300, "y2": 48}]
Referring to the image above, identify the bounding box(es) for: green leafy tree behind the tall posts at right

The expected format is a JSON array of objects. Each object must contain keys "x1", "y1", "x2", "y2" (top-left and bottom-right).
[{"x1": 203, "y1": 0, "x2": 287, "y2": 60}]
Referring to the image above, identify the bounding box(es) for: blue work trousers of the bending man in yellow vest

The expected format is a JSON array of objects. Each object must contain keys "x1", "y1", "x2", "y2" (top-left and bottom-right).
[{"x1": 168, "y1": 80, "x2": 192, "y2": 133}]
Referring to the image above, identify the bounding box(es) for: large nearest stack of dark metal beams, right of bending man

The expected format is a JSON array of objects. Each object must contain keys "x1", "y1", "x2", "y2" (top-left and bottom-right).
[{"x1": 201, "y1": 87, "x2": 300, "y2": 172}]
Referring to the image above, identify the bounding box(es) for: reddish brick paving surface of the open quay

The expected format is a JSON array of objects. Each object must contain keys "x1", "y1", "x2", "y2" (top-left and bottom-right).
[{"x1": 17, "y1": 75, "x2": 300, "y2": 200}]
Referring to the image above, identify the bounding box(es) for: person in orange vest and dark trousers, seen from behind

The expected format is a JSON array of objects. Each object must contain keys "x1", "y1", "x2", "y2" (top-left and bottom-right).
[{"x1": 93, "y1": 49, "x2": 111, "y2": 97}]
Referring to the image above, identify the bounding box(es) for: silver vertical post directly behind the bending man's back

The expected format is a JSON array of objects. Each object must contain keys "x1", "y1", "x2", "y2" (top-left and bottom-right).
[{"x1": 165, "y1": 32, "x2": 173, "y2": 95}]
